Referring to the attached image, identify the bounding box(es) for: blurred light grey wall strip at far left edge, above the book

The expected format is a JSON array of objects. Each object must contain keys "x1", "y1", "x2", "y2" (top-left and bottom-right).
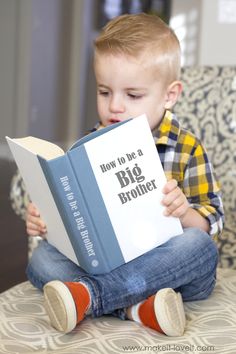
[{"x1": 0, "y1": 0, "x2": 31, "y2": 156}]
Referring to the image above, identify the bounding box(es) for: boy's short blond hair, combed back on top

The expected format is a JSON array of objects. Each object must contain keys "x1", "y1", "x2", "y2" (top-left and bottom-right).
[{"x1": 94, "y1": 13, "x2": 180, "y2": 84}]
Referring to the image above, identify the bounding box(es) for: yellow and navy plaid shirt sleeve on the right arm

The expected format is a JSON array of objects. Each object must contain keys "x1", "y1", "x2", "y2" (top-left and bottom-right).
[{"x1": 178, "y1": 131, "x2": 224, "y2": 236}]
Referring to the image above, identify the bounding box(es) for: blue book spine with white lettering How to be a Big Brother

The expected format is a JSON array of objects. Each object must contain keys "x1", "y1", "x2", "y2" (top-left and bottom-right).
[{"x1": 38, "y1": 155, "x2": 110, "y2": 274}]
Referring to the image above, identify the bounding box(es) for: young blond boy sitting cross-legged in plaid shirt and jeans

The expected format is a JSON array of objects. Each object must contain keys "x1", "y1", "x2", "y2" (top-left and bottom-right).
[{"x1": 27, "y1": 14, "x2": 223, "y2": 336}]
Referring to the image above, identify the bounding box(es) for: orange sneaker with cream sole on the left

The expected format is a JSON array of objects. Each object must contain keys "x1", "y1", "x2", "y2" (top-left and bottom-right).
[{"x1": 43, "y1": 280, "x2": 91, "y2": 333}]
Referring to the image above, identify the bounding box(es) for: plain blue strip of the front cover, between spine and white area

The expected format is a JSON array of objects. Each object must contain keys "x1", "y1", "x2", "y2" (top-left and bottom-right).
[{"x1": 68, "y1": 145, "x2": 125, "y2": 270}]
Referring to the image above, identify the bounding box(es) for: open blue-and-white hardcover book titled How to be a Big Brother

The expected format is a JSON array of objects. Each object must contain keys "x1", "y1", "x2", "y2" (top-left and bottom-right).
[{"x1": 6, "y1": 115, "x2": 183, "y2": 274}]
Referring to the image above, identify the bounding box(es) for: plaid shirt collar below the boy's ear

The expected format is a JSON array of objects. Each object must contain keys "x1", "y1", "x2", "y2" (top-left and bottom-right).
[{"x1": 153, "y1": 111, "x2": 180, "y2": 147}]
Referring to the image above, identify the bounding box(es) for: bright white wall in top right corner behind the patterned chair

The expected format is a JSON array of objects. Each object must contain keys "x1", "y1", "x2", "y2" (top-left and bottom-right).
[{"x1": 171, "y1": 0, "x2": 236, "y2": 66}]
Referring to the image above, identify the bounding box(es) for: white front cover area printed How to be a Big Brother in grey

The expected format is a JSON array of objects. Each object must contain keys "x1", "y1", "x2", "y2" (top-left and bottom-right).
[{"x1": 85, "y1": 116, "x2": 182, "y2": 262}]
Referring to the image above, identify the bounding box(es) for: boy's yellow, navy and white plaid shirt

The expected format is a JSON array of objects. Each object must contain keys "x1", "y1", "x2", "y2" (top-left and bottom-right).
[{"x1": 94, "y1": 111, "x2": 224, "y2": 237}]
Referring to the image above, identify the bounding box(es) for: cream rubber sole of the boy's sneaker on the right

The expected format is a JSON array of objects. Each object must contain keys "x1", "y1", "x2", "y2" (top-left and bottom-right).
[{"x1": 154, "y1": 288, "x2": 186, "y2": 337}]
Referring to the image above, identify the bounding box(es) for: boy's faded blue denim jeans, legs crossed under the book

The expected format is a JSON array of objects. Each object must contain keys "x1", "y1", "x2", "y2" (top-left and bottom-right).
[{"x1": 27, "y1": 228, "x2": 218, "y2": 319}]
